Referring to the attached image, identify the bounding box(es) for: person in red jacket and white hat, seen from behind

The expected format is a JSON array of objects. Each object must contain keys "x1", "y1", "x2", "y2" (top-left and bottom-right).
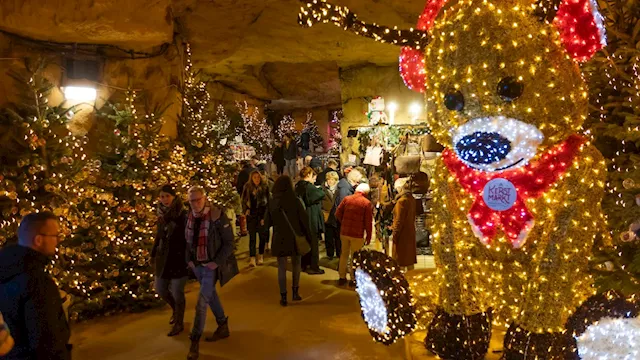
[{"x1": 336, "y1": 184, "x2": 373, "y2": 287}]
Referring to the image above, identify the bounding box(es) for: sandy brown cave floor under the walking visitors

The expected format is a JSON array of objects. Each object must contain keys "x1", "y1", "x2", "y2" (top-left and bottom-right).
[{"x1": 72, "y1": 238, "x2": 404, "y2": 360}]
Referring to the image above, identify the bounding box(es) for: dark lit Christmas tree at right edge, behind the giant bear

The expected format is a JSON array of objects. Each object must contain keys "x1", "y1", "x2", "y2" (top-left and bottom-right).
[{"x1": 585, "y1": 0, "x2": 640, "y2": 294}]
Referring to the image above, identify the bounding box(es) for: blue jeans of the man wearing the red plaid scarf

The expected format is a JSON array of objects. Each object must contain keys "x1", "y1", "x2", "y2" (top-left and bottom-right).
[{"x1": 191, "y1": 265, "x2": 227, "y2": 339}]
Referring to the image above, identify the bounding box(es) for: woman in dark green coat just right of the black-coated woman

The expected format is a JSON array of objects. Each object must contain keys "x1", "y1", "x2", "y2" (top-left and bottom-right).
[{"x1": 296, "y1": 166, "x2": 324, "y2": 275}]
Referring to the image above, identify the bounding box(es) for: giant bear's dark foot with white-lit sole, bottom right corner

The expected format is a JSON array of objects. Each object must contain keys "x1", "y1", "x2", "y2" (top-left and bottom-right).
[{"x1": 567, "y1": 291, "x2": 640, "y2": 360}]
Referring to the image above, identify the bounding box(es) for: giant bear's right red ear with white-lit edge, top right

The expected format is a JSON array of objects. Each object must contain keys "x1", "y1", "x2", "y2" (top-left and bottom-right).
[{"x1": 539, "y1": 0, "x2": 607, "y2": 61}]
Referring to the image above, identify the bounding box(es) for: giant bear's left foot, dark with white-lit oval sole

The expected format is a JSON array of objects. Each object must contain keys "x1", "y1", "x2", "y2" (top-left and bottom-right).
[{"x1": 353, "y1": 250, "x2": 416, "y2": 345}]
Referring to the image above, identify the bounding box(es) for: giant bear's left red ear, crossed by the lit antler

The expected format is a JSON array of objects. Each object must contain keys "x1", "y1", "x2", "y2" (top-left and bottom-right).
[{"x1": 400, "y1": 0, "x2": 447, "y2": 92}]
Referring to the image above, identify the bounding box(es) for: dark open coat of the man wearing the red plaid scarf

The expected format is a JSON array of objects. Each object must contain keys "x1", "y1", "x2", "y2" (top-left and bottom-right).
[{"x1": 185, "y1": 206, "x2": 240, "y2": 286}]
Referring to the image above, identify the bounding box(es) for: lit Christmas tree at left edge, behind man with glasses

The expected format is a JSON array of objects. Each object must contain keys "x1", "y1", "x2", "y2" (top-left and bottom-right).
[{"x1": 0, "y1": 60, "x2": 86, "y2": 245}]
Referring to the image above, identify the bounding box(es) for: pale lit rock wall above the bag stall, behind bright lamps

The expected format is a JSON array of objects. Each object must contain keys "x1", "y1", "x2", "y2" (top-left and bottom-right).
[{"x1": 340, "y1": 64, "x2": 426, "y2": 153}]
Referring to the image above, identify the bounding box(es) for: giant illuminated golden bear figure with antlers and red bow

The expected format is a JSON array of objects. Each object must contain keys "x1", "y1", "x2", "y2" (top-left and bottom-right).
[{"x1": 300, "y1": 0, "x2": 637, "y2": 360}]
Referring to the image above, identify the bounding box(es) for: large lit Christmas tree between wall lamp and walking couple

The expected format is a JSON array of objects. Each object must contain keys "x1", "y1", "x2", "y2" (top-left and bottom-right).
[{"x1": 54, "y1": 91, "x2": 171, "y2": 319}]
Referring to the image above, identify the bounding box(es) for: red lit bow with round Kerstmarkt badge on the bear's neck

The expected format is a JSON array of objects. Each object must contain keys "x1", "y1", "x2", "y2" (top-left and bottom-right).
[{"x1": 442, "y1": 135, "x2": 585, "y2": 248}]
